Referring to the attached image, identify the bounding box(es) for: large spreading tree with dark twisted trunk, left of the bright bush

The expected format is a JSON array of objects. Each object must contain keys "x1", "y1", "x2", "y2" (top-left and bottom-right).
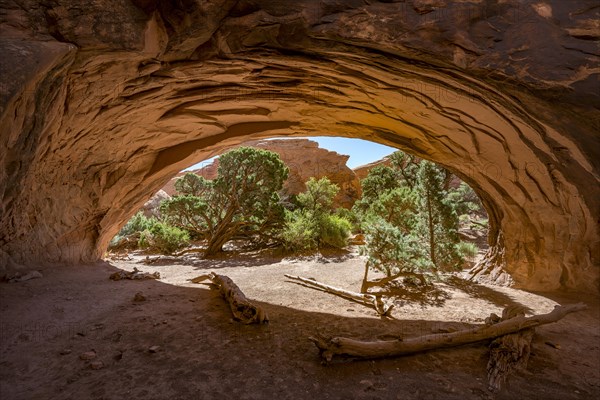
[{"x1": 161, "y1": 147, "x2": 288, "y2": 255}]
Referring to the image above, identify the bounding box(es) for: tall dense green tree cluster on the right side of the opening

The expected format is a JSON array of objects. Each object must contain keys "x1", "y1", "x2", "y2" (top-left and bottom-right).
[{"x1": 353, "y1": 152, "x2": 479, "y2": 282}]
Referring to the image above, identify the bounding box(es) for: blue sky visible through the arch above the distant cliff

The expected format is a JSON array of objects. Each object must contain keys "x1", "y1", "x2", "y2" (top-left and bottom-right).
[{"x1": 186, "y1": 136, "x2": 396, "y2": 170}]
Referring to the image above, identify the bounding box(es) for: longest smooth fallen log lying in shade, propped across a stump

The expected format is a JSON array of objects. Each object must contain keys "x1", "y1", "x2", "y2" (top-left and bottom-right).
[{"x1": 309, "y1": 303, "x2": 587, "y2": 362}]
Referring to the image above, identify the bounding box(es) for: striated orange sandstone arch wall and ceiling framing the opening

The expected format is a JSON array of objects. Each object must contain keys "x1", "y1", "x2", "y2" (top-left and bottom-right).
[{"x1": 0, "y1": 0, "x2": 600, "y2": 290}]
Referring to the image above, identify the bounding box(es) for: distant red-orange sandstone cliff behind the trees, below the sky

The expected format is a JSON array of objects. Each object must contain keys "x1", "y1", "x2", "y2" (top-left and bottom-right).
[{"x1": 162, "y1": 139, "x2": 361, "y2": 208}]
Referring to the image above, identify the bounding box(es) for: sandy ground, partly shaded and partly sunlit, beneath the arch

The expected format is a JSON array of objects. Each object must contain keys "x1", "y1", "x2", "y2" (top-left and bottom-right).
[{"x1": 0, "y1": 248, "x2": 600, "y2": 400}]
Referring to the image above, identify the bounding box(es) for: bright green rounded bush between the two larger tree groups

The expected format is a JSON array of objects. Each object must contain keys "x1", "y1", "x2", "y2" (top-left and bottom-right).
[{"x1": 281, "y1": 177, "x2": 352, "y2": 252}]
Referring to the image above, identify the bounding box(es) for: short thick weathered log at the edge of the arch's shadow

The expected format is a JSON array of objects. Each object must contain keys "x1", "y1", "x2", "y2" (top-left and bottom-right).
[{"x1": 191, "y1": 272, "x2": 269, "y2": 324}]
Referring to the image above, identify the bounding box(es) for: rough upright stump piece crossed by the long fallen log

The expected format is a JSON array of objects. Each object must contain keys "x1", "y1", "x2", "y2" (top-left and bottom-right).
[{"x1": 487, "y1": 306, "x2": 535, "y2": 392}]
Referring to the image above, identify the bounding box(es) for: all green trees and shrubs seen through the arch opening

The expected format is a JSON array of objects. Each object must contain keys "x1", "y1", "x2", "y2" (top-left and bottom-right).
[{"x1": 110, "y1": 147, "x2": 487, "y2": 282}]
